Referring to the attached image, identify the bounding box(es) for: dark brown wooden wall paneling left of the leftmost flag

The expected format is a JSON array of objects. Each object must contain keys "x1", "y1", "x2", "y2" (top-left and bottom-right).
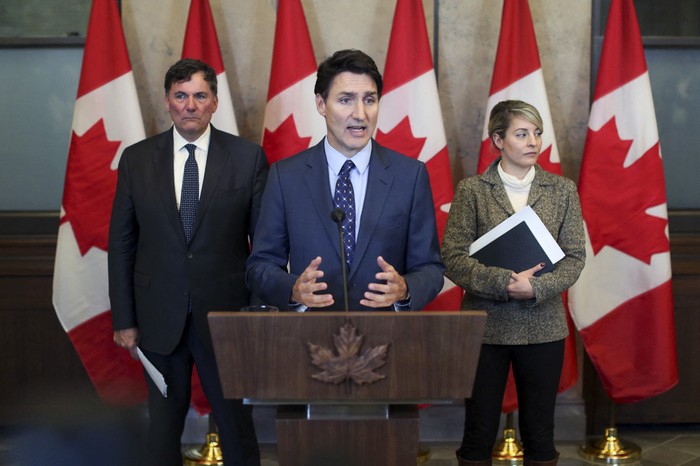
[{"x1": 0, "y1": 214, "x2": 95, "y2": 424}]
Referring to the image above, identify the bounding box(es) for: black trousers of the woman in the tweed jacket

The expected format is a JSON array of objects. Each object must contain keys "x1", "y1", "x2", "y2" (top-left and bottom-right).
[{"x1": 458, "y1": 340, "x2": 564, "y2": 461}]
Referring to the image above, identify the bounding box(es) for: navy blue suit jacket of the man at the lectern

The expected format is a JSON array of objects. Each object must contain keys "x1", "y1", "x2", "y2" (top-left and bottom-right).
[{"x1": 246, "y1": 140, "x2": 444, "y2": 310}]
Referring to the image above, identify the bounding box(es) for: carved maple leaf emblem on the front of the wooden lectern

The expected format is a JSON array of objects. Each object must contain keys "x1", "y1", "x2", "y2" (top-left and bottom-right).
[{"x1": 307, "y1": 322, "x2": 389, "y2": 385}]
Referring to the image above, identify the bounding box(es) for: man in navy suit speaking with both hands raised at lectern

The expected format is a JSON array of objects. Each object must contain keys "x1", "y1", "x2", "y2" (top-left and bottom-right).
[{"x1": 246, "y1": 50, "x2": 444, "y2": 311}]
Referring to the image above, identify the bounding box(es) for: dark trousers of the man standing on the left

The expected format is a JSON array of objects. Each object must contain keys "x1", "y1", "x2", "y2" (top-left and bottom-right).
[{"x1": 144, "y1": 319, "x2": 260, "y2": 466}]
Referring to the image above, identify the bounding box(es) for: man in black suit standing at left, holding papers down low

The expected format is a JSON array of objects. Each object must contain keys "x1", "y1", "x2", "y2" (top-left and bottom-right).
[{"x1": 109, "y1": 59, "x2": 268, "y2": 466}]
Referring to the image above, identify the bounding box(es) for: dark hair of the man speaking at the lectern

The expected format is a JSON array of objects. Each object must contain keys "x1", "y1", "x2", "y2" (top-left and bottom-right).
[{"x1": 314, "y1": 49, "x2": 383, "y2": 100}]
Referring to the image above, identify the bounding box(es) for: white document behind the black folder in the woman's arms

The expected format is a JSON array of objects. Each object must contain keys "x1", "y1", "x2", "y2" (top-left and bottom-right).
[{"x1": 469, "y1": 205, "x2": 566, "y2": 264}]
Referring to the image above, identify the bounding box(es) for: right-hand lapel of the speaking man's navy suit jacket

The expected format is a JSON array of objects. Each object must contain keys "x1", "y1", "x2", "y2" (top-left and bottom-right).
[{"x1": 350, "y1": 140, "x2": 394, "y2": 275}]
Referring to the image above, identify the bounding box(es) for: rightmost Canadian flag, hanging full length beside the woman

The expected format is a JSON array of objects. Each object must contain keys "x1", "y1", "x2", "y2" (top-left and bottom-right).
[{"x1": 569, "y1": 0, "x2": 678, "y2": 403}]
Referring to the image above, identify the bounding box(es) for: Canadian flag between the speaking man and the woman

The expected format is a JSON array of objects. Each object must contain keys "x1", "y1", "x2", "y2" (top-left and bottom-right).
[{"x1": 375, "y1": 0, "x2": 462, "y2": 310}]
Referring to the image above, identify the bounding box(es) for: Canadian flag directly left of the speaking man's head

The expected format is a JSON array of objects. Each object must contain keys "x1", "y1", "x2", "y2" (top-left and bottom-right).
[{"x1": 262, "y1": 0, "x2": 326, "y2": 164}]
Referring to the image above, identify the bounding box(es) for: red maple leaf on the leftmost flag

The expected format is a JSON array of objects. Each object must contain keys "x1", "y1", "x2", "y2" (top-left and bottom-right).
[{"x1": 61, "y1": 119, "x2": 121, "y2": 255}]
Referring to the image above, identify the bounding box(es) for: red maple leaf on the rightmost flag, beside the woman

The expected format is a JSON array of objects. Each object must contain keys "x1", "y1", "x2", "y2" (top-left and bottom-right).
[{"x1": 580, "y1": 118, "x2": 669, "y2": 264}]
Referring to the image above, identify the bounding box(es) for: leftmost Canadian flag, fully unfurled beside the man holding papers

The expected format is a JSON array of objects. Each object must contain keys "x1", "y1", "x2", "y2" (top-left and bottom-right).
[{"x1": 53, "y1": 0, "x2": 146, "y2": 404}]
